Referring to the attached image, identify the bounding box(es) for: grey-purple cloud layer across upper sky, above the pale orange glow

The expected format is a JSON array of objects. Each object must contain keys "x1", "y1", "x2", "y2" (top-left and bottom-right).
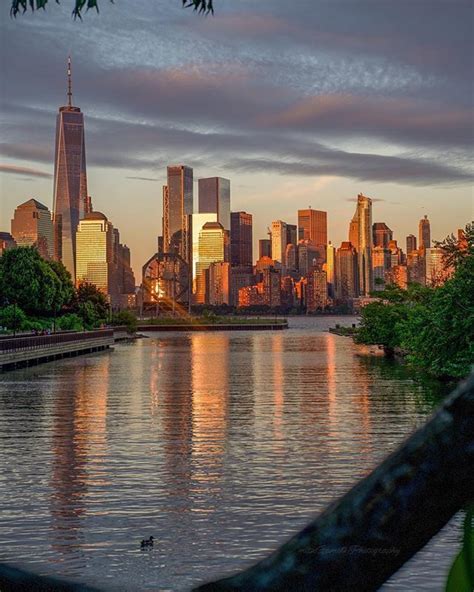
[{"x1": 0, "y1": 0, "x2": 473, "y2": 190}]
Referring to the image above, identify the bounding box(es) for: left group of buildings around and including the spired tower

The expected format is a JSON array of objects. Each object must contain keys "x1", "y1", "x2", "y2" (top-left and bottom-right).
[{"x1": 0, "y1": 60, "x2": 135, "y2": 307}]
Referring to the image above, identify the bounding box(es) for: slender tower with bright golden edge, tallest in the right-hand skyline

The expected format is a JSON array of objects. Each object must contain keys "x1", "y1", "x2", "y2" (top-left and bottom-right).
[{"x1": 349, "y1": 193, "x2": 373, "y2": 296}]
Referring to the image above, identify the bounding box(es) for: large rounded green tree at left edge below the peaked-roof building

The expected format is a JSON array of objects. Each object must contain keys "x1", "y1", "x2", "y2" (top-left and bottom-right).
[{"x1": 0, "y1": 247, "x2": 62, "y2": 315}]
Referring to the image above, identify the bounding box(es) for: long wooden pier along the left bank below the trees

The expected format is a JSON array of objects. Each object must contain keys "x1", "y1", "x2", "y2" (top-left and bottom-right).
[{"x1": 0, "y1": 329, "x2": 114, "y2": 371}]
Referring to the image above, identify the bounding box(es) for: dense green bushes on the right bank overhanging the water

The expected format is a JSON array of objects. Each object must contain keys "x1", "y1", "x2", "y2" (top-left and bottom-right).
[{"x1": 356, "y1": 256, "x2": 474, "y2": 378}]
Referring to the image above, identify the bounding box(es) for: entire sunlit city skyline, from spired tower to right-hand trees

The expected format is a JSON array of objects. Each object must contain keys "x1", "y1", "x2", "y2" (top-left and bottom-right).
[{"x1": 0, "y1": 61, "x2": 458, "y2": 311}]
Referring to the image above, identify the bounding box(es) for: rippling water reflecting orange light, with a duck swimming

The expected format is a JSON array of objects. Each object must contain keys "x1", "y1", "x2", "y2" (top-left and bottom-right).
[{"x1": 0, "y1": 317, "x2": 459, "y2": 592}]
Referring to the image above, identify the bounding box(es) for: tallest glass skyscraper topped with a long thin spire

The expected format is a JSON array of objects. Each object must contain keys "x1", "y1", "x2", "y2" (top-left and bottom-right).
[{"x1": 53, "y1": 58, "x2": 87, "y2": 280}]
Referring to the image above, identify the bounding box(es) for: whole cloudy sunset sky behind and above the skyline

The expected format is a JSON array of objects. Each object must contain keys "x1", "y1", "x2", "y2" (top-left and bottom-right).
[{"x1": 0, "y1": 0, "x2": 474, "y2": 282}]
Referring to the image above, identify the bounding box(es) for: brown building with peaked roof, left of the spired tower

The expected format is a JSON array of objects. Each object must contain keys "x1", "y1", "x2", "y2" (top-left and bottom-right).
[{"x1": 11, "y1": 199, "x2": 54, "y2": 259}]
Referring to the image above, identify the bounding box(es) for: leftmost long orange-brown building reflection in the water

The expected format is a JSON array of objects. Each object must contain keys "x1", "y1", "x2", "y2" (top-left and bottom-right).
[{"x1": 50, "y1": 356, "x2": 110, "y2": 561}]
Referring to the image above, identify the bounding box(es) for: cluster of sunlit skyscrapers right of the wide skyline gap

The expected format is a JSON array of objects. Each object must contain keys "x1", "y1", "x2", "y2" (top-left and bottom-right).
[{"x1": 141, "y1": 172, "x2": 449, "y2": 311}]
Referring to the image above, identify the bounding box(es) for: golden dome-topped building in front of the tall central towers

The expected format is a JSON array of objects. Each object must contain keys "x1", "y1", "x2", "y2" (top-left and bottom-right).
[{"x1": 196, "y1": 222, "x2": 228, "y2": 304}]
